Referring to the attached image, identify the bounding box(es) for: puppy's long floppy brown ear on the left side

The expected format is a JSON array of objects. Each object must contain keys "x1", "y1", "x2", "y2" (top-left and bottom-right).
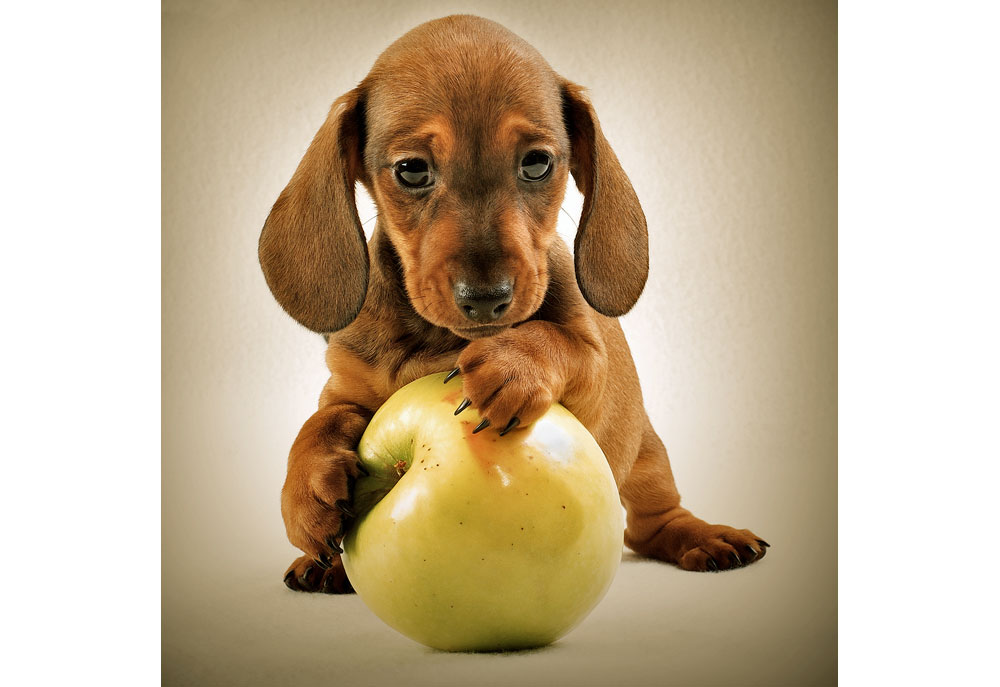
[{"x1": 257, "y1": 87, "x2": 368, "y2": 332}]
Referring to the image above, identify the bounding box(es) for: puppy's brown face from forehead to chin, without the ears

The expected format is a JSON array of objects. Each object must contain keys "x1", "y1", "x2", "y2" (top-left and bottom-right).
[{"x1": 365, "y1": 43, "x2": 570, "y2": 339}]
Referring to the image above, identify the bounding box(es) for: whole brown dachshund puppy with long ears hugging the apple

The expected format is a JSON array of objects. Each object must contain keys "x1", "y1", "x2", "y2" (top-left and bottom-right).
[{"x1": 260, "y1": 16, "x2": 768, "y2": 592}]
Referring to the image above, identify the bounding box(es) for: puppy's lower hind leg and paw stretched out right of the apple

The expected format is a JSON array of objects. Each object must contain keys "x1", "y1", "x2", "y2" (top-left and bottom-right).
[{"x1": 621, "y1": 426, "x2": 770, "y2": 571}]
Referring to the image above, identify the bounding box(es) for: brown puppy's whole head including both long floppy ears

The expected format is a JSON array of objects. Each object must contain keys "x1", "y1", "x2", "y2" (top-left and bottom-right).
[{"x1": 260, "y1": 16, "x2": 648, "y2": 339}]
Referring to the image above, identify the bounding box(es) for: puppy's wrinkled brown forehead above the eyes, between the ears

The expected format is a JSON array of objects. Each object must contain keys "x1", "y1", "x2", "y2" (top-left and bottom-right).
[{"x1": 365, "y1": 30, "x2": 567, "y2": 162}]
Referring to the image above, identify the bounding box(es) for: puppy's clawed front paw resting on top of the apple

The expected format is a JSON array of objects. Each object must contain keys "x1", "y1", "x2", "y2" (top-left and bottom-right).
[{"x1": 458, "y1": 333, "x2": 559, "y2": 434}]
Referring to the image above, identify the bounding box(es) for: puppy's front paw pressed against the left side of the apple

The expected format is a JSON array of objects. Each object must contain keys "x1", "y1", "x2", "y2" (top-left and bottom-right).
[{"x1": 281, "y1": 450, "x2": 361, "y2": 568}]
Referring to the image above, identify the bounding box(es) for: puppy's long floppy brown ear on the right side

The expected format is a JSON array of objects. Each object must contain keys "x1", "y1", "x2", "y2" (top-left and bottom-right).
[{"x1": 561, "y1": 81, "x2": 649, "y2": 317}]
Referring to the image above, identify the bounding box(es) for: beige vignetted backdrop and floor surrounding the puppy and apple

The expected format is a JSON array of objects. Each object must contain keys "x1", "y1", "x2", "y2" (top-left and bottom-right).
[{"x1": 162, "y1": 0, "x2": 837, "y2": 685}]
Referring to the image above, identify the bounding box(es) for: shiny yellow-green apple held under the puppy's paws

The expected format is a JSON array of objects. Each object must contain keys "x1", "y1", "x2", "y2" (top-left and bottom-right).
[{"x1": 343, "y1": 374, "x2": 624, "y2": 651}]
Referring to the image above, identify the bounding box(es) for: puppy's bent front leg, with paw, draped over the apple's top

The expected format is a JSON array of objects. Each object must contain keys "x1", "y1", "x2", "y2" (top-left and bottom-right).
[{"x1": 458, "y1": 320, "x2": 607, "y2": 432}]
